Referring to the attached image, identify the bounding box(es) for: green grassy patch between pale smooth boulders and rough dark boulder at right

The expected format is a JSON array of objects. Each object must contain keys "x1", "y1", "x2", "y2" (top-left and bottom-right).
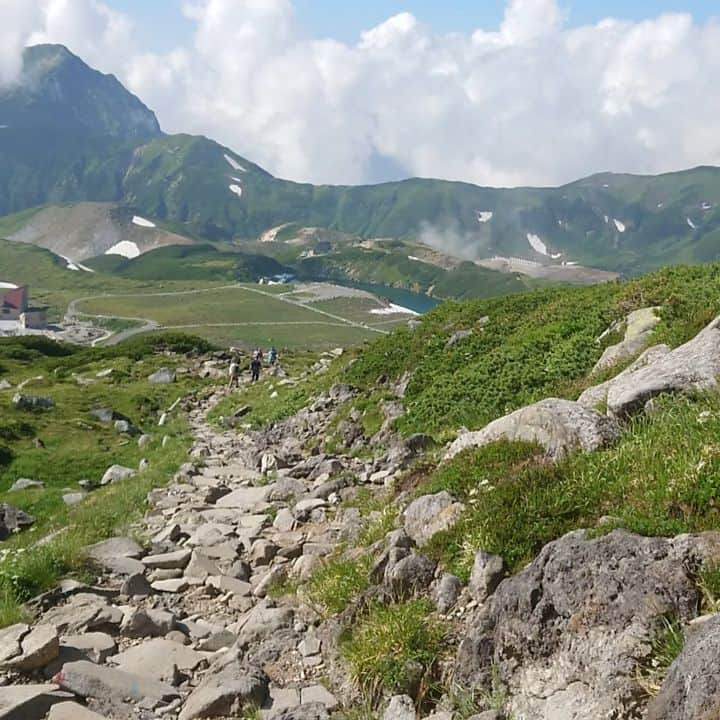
[{"x1": 423, "y1": 394, "x2": 720, "y2": 576}]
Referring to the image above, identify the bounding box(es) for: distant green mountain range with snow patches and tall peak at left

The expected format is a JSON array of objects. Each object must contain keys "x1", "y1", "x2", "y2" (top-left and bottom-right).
[{"x1": 0, "y1": 46, "x2": 720, "y2": 274}]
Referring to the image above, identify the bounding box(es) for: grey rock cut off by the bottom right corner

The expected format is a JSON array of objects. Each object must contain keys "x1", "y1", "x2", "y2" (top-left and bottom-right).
[{"x1": 645, "y1": 615, "x2": 720, "y2": 720}]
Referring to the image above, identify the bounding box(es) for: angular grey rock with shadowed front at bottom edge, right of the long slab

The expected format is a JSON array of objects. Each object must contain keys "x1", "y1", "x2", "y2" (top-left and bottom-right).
[{"x1": 178, "y1": 669, "x2": 268, "y2": 720}]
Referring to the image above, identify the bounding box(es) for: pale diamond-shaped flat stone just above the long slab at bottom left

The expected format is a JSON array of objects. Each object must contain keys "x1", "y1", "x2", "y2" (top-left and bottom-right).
[{"x1": 113, "y1": 638, "x2": 205, "y2": 685}]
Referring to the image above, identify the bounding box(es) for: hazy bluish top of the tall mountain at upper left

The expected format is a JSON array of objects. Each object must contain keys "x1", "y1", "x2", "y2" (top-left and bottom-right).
[{"x1": 0, "y1": 45, "x2": 161, "y2": 139}]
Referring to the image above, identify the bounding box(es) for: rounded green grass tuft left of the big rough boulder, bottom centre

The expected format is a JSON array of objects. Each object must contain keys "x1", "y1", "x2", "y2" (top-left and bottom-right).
[{"x1": 341, "y1": 600, "x2": 446, "y2": 705}]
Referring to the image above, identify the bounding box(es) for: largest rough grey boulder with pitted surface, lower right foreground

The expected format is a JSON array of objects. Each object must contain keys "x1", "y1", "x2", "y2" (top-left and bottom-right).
[{"x1": 455, "y1": 530, "x2": 720, "y2": 720}]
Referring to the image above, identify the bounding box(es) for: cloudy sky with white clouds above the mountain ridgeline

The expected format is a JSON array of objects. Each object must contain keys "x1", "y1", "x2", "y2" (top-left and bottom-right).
[{"x1": 0, "y1": 0, "x2": 720, "y2": 186}]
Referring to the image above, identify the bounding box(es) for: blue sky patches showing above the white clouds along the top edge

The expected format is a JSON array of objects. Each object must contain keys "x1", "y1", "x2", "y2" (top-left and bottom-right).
[{"x1": 106, "y1": 0, "x2": 720, "y2": 52}]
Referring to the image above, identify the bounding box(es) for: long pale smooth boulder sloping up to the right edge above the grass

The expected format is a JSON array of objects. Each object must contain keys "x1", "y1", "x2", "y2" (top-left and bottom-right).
[{"x1": 607, "y1": 316, "x2": 720, "y2": 418}]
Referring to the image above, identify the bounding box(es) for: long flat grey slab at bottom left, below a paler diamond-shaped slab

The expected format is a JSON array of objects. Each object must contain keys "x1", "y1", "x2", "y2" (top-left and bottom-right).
[{"x1": 54, "y1": 660, "x2": 179, "y2": 706}]
